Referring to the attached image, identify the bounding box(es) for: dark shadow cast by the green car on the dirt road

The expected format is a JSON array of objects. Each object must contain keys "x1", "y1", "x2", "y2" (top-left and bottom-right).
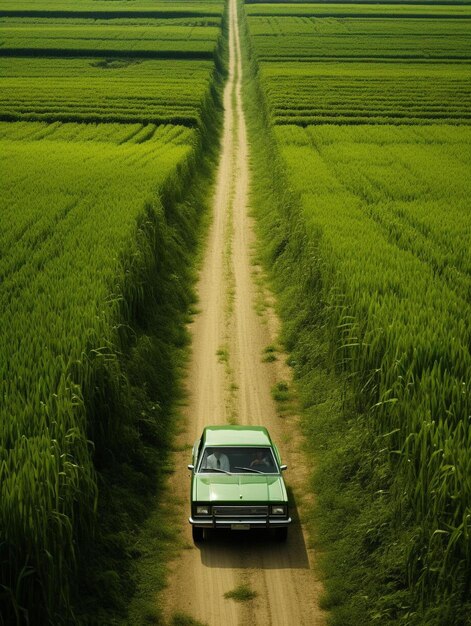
[{"x1": 196, "y1": 494, "x2": 309, "y2": 569}]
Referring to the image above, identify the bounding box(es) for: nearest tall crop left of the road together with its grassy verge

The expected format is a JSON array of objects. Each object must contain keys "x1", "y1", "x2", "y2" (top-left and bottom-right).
[{"x1": 0, "y1": 0, "x2": 227, "y2": 626}]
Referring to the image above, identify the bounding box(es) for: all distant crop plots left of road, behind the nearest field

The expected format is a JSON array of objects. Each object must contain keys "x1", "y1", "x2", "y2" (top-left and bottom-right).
[{"x1": 0, "y1": 1, "x2": 223, "y2": 126}]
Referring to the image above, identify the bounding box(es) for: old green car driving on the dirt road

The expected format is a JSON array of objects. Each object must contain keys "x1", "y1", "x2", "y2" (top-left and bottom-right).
[{"x1": 188, "y1": 426, "x2": 291, "y2": 542}]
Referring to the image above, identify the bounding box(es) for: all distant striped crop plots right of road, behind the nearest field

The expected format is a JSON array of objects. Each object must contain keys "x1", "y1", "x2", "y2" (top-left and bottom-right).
[{"x1": 246, "y1": 3, "x2": 471, "y2": 126}]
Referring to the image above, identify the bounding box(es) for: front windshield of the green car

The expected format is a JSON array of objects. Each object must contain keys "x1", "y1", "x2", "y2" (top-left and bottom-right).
[{"x1": 198, "y1": 446, "x2": 278, "y2": 475}]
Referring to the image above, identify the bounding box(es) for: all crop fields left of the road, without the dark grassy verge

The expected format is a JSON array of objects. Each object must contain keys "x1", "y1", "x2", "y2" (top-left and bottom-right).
[{"x1": 0, "y1": 0, "x2": 224, "y2": 624}]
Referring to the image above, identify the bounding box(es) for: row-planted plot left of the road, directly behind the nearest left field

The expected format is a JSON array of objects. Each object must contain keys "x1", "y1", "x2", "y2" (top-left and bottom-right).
[{"x1": 0, "y1": 58, "x2": 218, "y2": 125}]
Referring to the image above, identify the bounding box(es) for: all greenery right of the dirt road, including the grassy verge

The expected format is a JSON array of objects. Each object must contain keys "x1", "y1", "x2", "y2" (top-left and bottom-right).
[{"x1": 243, "y1": 4, "x2": 471, "y2": 626}]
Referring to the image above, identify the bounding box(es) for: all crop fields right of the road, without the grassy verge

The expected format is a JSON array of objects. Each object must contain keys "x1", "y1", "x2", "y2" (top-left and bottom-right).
[{"x1": 247, "y1": 3, "x2": 471, "y2": 623}]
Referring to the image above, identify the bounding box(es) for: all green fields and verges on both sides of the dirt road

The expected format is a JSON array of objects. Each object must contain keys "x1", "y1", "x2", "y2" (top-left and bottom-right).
[{"x1": 0, "y1": 0, "x2": 471, "y2": 626}]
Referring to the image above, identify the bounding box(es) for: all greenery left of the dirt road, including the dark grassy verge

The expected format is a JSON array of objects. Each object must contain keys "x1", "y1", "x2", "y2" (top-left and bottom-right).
[{"x1": 0, "y1": 2, "x2": 224, "y2": 626}]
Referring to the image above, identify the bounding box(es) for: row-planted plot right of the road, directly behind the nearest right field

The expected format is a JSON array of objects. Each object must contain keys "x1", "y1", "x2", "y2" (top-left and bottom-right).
[{"x1": 260, "y1": 62, "x2": 471, "y2": 125}]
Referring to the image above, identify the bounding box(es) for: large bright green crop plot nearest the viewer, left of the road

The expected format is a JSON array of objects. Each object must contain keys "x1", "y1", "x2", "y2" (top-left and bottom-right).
[{"x1": 0, "y1": 123, "x2": 200, "y2": 623}]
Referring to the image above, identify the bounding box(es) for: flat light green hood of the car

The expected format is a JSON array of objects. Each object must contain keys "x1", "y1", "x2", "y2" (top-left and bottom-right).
[{"x1": 193, "y1": 474, "x2": 288, "y2": 502}]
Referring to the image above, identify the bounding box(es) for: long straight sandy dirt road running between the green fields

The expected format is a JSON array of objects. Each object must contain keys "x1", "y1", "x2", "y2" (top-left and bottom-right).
[{"x1": 164, "y1": 0, "x2": 324, "y2": 626}]
